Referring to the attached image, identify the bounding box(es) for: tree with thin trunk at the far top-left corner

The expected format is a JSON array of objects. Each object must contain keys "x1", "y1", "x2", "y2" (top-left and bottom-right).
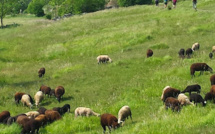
[{"x1": 0, "y1": 0, "x2": 15, "y2": 28}]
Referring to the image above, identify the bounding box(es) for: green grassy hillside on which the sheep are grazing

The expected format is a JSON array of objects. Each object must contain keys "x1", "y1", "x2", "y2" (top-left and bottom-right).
[{"x1": 0, "y1": 0, "x2": 215, "y2": 134}]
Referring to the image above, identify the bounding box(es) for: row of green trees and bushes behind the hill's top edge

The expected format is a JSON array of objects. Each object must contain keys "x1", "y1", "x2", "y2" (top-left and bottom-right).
[{"x1": 8, "y1": 0, "x2": 153, "y2": 19}]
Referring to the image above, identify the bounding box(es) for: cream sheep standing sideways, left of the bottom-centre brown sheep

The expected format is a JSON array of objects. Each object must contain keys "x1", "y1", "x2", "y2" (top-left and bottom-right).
[{"x1": 75, "y1": 107, "x2": 100, "y2": 117}]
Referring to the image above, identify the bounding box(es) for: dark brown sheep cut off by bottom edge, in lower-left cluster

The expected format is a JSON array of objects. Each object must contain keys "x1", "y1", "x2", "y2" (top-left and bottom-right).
[{"x1": 21, "y1": 119, "x2": 42, "y2": 134}]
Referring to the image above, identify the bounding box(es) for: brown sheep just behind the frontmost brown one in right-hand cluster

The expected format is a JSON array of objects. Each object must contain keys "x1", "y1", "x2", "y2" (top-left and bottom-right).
[{"x1": 163, "y1": 87, "x2": 181, "y2": 102}]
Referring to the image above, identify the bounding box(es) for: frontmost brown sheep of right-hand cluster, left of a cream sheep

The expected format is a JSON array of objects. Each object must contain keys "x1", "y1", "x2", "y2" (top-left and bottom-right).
[{"x1": 165, "y1": 97, "x2": 181, "y2": 112}]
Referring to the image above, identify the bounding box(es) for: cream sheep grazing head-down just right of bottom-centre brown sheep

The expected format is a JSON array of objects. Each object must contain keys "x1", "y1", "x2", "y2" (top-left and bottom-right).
[{"x1": 118, "y1": 106, "x2": 132, "y2": 126}]
